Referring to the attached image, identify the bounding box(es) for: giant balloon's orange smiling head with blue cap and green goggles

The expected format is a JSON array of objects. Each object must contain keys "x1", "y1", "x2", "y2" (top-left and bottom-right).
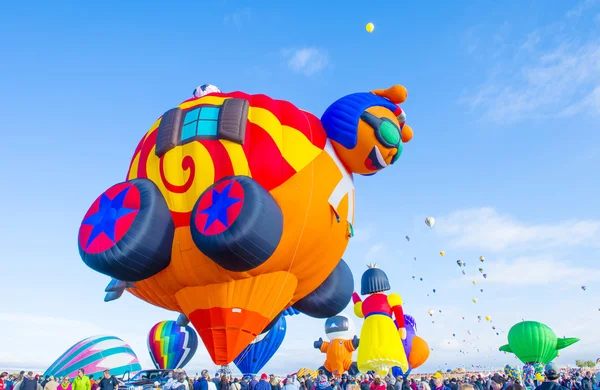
[{"x1": 322, "y1": 86, "x2": 413, "y2": 175}]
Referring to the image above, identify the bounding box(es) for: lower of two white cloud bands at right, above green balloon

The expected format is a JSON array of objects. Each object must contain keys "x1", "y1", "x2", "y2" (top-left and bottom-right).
[{"x1": 486, "y1": 255, "x2": 600, "y2": 286}]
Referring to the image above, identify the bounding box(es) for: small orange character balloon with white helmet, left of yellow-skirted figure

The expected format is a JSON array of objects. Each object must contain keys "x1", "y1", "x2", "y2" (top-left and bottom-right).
[{"x1": 314, "y1": 314, "x2": 359, "y2": 377}]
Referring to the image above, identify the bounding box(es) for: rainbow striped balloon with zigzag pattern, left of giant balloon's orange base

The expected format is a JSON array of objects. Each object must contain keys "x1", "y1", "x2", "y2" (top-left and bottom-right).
[{"x1": 148, "y1": 321, "x2": 198, "y2": 370}]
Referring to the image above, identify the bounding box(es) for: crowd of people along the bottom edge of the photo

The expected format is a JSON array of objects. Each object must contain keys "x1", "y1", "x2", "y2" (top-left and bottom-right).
[{"x1": 0, "y1": 363, "x2": 600, "y2": 390}]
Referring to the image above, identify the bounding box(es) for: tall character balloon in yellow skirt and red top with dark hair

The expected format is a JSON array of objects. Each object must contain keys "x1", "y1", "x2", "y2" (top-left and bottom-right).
[{"x1": 352, "y1": 264, "x2": 408, "y2": 376}]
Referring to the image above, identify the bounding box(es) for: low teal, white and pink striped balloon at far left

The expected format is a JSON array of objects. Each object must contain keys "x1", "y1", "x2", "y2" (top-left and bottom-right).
[{"x1": 44, "y1": 336, "x2": 142, "y2": 378}]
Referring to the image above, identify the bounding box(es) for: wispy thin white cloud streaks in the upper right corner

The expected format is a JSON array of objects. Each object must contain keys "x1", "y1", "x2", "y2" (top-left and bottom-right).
[{"x1": 462, "y1": 1, "x2": 600, "y2": 122}]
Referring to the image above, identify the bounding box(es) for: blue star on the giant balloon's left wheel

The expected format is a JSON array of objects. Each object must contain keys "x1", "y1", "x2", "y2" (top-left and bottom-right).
[{"x1": 81, "y1": 187, "x2": 138, "y2": 248}]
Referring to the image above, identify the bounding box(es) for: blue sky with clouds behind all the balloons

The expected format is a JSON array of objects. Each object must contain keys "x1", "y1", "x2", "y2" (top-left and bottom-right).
[{"x1": 0, "y1": 0, "x2": 600, "y2": 373}]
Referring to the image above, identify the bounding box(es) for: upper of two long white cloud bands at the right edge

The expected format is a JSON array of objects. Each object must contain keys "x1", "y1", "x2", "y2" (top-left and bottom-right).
[{"x1": 436, "y1": 207, "x2": 600, "y2": 251}]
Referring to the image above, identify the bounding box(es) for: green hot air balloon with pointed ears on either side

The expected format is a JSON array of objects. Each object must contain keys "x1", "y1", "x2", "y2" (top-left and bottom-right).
[{"x1": 500, "y1": 321, "x2": 579, "y2": 364}]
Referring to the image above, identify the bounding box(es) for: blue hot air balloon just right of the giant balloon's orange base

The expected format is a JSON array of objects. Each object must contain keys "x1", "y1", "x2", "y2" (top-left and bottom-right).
[{"x1": 233, "y1": 316, "x2": 287, "y2": 375}]
